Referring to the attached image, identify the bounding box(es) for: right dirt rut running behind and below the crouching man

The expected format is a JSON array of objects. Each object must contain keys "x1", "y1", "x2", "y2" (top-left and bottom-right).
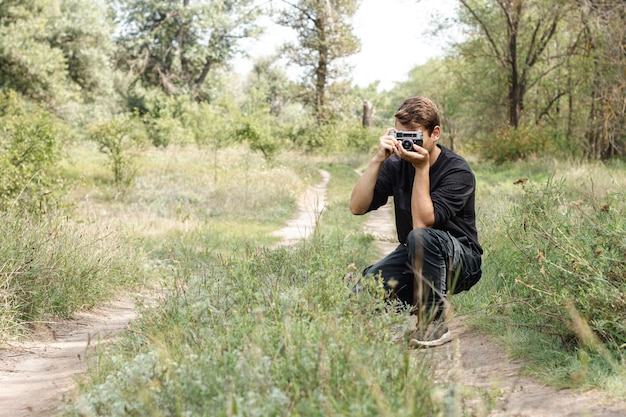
[{"x1": 366, "y1": 204, "x2": 626, "y2": 417}]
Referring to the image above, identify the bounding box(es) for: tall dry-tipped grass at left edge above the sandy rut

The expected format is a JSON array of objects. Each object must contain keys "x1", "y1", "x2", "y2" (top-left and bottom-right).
[{"x1": 0, "y1": 209, "x2": 148, "y2": 342}]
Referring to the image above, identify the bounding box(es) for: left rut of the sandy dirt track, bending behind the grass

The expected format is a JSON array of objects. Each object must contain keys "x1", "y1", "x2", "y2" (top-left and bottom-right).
[{"x1": 0, "y1": 171, "x2": 330, "y2": 417}]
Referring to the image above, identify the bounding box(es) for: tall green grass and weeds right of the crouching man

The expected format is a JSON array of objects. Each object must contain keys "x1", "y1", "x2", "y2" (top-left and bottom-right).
[{"x1": 457, "y1": 156, "x2": 626, "y2": 396}]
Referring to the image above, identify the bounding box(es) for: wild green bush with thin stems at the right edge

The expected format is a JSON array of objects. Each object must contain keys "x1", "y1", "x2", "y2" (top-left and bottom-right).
[{"x1": 508, "y1": 183, "x2": 626, "y2": 353}]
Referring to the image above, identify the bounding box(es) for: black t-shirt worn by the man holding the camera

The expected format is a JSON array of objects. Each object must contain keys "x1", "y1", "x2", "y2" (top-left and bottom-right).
[{"x1": 367, "y1": 145, "x2": 483, "y2": 254}]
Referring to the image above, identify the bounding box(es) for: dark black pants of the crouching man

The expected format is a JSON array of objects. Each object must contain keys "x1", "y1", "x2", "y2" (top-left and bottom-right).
[{"x1": 363, "y1": 228, "x2": 482, "y2": 318}]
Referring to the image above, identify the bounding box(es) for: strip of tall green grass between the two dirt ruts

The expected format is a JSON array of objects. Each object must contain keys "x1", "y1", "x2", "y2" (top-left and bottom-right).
[{"x1": 62, "y1": 156, "x2": 454, "y2": 416}]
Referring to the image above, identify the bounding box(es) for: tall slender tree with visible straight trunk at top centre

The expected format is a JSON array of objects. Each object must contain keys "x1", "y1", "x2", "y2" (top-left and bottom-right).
[{"x1": 278, "y1": 0, "x2": 360, "y2": 124}]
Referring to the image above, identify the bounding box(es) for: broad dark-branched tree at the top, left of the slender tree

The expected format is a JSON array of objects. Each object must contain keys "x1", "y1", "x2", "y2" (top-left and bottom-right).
[{"x1": 117, "y1": 0, "x2": 259, "y2": 101}]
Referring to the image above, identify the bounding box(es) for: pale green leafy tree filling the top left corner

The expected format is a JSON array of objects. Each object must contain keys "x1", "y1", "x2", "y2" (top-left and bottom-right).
[{"x1": 0, "y1": 0, "x2": 112, "y2": 107}]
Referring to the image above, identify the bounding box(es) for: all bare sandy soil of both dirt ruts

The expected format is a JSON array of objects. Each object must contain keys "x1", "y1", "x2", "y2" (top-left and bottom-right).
[{"x1": 0, "y1": 171, "x2": 626, "y2": 417}]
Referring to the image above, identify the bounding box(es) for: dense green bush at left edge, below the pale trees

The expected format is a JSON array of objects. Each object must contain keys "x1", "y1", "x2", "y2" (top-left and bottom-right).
[{"x1": 0, "y1": 93, "x2": 68, "y2": 211}]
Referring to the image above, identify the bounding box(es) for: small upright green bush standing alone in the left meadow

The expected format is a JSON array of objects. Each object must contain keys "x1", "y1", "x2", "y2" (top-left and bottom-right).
[{"x1": 89, "y1": 116, "x2": 145, "y2": 188}]
